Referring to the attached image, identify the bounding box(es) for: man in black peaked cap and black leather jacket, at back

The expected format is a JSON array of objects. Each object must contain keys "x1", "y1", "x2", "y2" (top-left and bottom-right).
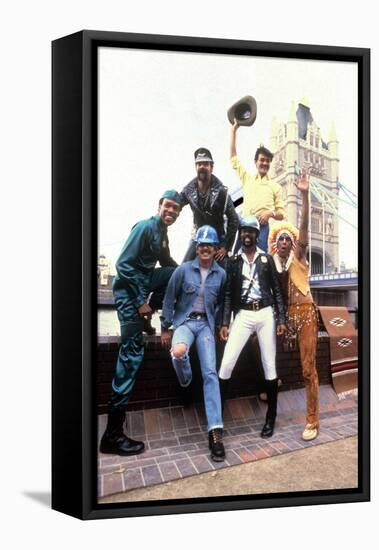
[{"x1": 180, "y1": 147, "x2": 238, "y2": 262}]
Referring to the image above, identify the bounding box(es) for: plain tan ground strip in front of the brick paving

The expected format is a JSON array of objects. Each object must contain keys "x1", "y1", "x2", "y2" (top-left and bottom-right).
[{"x1": 99, "y1": 435, "x2": 358, "y2": 504}]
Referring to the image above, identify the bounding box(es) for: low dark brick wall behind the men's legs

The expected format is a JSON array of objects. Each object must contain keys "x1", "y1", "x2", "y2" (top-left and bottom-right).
[{"x1": 97, "y1": 333, "x2": 331, "y2": 413}]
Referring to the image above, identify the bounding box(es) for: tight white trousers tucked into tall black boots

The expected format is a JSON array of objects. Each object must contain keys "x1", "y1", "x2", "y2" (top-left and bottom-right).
[{"x1": 219, "y1": 306, "x2": 277, "y2": 380}]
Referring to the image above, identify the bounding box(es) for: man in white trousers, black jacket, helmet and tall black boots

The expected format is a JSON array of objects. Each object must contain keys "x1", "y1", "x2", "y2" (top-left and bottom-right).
[{"x1": 219, "y1": 216, "x2": 286, "y2": 437}]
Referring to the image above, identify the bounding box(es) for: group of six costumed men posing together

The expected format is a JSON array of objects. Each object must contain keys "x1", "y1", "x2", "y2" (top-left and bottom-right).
[{"x1": 100, "y1": 121, "x2": 319, "y2": 461}]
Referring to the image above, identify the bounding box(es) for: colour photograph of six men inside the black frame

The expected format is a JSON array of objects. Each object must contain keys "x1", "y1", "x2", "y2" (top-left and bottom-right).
[{"x1": 96, "y1": 47, "x2": 359, "y2": 504}]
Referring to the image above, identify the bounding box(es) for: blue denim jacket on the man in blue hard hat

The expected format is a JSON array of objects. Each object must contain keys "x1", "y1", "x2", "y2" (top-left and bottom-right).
[{"x1": 161, "y1": 258, "x2": 226, "y2": 330}]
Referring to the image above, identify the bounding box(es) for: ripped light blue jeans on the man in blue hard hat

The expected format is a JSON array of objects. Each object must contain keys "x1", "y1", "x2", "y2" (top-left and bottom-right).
[{"x1": 172, "y1": 319, "x2": 223, "y2": 431}]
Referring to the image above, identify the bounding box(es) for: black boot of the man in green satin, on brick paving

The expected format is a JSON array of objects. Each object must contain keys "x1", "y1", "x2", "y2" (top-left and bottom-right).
[{"x1": 100, "y1": 411, "x2": 145, "y2": 456}]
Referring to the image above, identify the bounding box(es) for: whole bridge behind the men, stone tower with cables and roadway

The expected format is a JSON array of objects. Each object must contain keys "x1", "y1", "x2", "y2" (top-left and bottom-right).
[{"x1": 231, "y1": 98, "x2": 358, "y2": 313}]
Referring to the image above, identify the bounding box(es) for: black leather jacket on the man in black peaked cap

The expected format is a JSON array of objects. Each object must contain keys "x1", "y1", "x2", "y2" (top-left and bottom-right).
[{"x1": 180, "y1": 174, "x2": 239, "y2": 251}]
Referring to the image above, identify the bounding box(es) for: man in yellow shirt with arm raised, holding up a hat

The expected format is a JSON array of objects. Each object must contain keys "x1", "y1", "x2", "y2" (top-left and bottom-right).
[{"x1": 230, "y1": 119, "x2": 285, "y2": 252}]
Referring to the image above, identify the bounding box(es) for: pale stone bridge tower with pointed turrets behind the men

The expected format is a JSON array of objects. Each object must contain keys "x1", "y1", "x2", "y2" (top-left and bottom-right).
[{"x1": 270, "y1": 98, "x2": 339, "y2": 274}]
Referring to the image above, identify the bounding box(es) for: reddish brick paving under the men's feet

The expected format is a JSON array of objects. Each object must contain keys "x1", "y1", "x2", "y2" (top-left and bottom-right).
[{"x1": 98, "y1": 386, "x2": 358, "y2": 498}]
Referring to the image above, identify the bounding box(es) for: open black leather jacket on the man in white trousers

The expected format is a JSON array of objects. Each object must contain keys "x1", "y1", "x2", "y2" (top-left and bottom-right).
[{"x1": 222, "y1": 252, "x2": 285, "y2": 326}]
